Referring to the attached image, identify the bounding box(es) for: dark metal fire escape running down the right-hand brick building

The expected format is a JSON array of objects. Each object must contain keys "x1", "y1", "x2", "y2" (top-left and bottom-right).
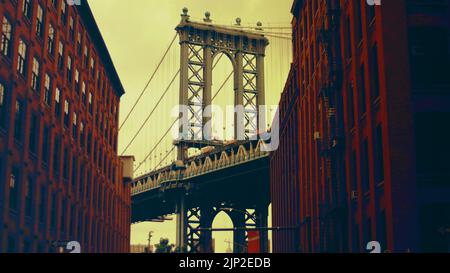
[{"x1": 317, "y1": 0, "x2": 347, "y2": 252}]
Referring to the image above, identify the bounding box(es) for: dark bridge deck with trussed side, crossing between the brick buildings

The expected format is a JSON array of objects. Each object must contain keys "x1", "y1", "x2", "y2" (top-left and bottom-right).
[{"x1": 132, "y1": 139, "x2": 269, "y2": 222}]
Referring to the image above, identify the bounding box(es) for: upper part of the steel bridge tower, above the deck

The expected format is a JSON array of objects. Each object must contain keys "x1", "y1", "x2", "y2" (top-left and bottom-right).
[{"x1": 176, "y1": 8, "x2": 269, "y2": 160}]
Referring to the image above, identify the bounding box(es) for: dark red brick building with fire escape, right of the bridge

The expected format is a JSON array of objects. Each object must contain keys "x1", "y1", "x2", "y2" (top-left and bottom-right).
[{"x1": 271, "y1": 0, "x2": 450, "y2": 252}]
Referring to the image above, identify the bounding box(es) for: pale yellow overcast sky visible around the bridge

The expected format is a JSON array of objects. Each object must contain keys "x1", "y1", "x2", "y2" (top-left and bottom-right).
[{"x1": 88, "y1": 0, "x2": 293, "y2": 252}]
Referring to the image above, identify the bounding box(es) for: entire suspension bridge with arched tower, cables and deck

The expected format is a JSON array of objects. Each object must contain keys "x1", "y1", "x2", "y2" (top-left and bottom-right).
[{"x1": 120, "y1": 9, "x2": 291, "y2": 252}]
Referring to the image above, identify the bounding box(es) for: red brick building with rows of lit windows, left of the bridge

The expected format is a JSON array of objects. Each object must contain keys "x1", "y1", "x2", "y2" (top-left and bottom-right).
[{"x1": 0, "y1": 0, "x2": 130, "y2": 252}]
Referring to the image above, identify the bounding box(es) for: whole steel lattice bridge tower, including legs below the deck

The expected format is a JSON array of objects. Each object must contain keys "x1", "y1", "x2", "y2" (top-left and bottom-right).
[{"x1": 175, "y1": 8, "x2": 269, "y2": 252}]
